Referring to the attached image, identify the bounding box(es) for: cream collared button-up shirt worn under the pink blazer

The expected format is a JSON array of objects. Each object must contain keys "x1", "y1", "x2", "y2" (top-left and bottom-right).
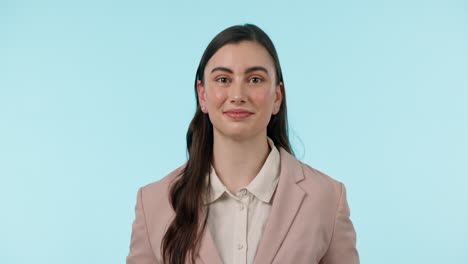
[{"x1": 204, "y1": 137, "x2": 280, "y2": 264}]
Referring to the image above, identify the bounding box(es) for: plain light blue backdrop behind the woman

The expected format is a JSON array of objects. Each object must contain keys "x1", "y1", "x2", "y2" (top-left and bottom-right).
[{"x1": 0, "y1": 0, "x2": 468, "y2": 264}]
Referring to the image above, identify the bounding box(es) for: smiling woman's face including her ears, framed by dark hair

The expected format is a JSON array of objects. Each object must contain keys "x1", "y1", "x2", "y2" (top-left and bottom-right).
[{"x1": 197, "y1": 41, "x2": 283, "y2": 139}]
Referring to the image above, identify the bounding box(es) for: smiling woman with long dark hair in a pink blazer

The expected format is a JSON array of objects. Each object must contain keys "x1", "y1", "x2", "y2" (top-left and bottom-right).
[{"x1": 127, "y1": 24, "x2": 359, "y2": 264}]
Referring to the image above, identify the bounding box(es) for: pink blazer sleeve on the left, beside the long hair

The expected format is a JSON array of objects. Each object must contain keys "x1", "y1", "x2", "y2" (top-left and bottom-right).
[{"x1": 127, "y1": 188, "x2": 159, "y2": 264}]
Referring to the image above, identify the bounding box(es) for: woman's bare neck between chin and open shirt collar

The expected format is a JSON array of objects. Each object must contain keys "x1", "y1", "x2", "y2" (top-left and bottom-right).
[{"x1": 213, "y1": 132, "x2": 271, "y2": 194}]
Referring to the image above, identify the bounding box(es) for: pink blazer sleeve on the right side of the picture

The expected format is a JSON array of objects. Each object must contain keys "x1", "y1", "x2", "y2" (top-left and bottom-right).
[{"x1": 320, "y1": 183, "x2": 359, "y2": 264}]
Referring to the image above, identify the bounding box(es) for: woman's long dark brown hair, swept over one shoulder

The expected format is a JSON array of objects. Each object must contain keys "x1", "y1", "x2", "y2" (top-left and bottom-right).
[{"x1": 161, "y1": 24, "x2": 294, "y2": 264}]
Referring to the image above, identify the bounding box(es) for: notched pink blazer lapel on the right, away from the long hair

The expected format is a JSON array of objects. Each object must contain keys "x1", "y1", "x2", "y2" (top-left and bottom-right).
[{"x1": 254, "y1": 147, "x2": 305, "y2": 264}]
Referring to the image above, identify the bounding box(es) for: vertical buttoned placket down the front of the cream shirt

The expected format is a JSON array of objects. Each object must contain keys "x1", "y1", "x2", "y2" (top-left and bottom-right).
[{"x1": 233, "y1": 189, "x2": 249, "y2": 264}]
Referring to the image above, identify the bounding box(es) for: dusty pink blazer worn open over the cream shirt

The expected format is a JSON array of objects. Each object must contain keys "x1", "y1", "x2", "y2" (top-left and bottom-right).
[{"x1": 127, "y1": 147, "x2": 359, "y2": 264}]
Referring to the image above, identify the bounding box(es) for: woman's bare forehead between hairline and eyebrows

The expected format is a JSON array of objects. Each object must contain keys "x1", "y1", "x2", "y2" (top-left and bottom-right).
[{"x1": 205, "y1": 41, "x2": 274, "y2": 73}]
